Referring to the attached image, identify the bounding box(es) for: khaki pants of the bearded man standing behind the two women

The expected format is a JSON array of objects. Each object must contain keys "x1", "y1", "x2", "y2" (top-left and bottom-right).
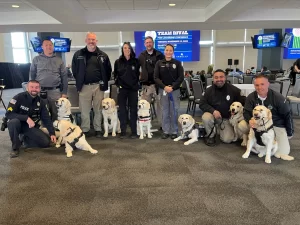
[{"x1": 142, "y1": 84, "x2": 162, "y2": 125}]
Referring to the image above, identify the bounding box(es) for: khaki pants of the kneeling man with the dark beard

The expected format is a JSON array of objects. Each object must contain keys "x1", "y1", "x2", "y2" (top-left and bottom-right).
[{"x1": 202, "y1": 112, "x2": 234, "y2": 143}]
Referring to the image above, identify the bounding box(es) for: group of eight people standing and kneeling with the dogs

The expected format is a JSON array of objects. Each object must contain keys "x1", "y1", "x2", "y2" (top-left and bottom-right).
[{"x1": 6, "y1": 30, "x2": 294, "y2": 157}]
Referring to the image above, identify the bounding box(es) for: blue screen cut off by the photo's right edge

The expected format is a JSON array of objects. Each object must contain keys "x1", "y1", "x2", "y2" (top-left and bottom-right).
[{"x1": 283, "y1": 28, "x2": 300, "y2": 59}]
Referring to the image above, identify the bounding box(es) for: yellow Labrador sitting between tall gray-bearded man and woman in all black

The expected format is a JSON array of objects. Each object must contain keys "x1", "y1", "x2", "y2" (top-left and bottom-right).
[{"x1": 102, "y1": 98, "x2": 121, "y2": 137}]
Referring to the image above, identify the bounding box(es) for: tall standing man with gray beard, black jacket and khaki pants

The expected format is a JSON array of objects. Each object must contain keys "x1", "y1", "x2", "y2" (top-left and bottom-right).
[{"x1": 72, "y1": 32, "x2": 111, "y2": 138}]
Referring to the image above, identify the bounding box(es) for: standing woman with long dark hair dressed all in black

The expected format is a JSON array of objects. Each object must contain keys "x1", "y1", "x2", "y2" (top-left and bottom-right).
[{"x1": 114, "y1": 42, "x2": 140, "y2": 138}]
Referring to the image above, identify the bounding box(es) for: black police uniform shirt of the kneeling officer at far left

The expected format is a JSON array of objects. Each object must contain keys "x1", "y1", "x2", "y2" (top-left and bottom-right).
[{"x1": 6, "y1": 91, "x2": 55, "y2": 135}]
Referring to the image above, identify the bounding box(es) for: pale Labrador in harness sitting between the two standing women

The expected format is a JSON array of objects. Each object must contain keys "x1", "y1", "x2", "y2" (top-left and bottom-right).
[{"x1": 137, "y1": 99, "x2": 152, "y2": 139}]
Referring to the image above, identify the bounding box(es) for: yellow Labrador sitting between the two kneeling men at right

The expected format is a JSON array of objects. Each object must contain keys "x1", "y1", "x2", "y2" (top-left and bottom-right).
[{"x1": 229, "y1": 102, "x2": 250, "y2": 146}]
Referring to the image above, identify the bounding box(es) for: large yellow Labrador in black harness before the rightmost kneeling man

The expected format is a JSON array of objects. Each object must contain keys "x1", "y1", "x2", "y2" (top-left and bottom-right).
[{"x1": 243, "y1": 105, "x2": 294, "y2": 163}]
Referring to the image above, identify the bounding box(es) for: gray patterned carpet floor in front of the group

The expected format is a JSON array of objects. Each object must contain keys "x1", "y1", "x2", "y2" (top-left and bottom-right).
[{"x1": 0, "y1": 89, "x2": 300, "y2": 225}]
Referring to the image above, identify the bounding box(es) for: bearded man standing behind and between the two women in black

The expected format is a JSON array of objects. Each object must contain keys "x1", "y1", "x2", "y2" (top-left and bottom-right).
[{"x1": 138, "y1": 36, "x2": 164, "y2": 123}]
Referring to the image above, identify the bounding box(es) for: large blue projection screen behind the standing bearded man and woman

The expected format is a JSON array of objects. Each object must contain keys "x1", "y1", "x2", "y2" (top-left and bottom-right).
[{"x1": 134, "y1": 30, "x2": 200, "y2": 62}]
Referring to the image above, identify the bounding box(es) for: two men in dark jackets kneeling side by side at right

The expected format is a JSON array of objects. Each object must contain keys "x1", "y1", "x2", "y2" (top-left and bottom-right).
[{"x1": 199, "y1": 70, "x2": 294, "y2": 155}]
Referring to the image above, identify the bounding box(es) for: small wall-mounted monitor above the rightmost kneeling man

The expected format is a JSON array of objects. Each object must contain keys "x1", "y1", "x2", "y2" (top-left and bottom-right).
[{"x1": 251, "y1": 33, "x2": 280, "y2": 49}]
